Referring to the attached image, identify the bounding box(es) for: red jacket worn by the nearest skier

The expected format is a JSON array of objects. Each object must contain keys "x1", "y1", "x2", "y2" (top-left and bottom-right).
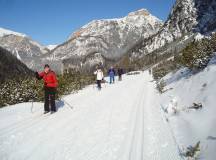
[{"x1": 39, "y1": 71, "x2": 58, "y2": 88}]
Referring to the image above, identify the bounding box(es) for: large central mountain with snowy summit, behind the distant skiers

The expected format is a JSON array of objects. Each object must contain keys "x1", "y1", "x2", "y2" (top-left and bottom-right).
[{"x1": 52, "y1": 9, "x2": 163, "y2": 71}]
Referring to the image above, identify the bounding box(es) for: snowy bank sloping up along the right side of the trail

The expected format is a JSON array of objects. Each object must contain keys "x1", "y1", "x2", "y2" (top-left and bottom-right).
[{"x1": 160, "y1": 56, "x2": 216, "y2": 160}]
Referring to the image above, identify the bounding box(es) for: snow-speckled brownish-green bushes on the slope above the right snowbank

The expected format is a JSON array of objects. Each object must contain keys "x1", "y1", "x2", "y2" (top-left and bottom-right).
[{"x1": 152, "y1": 34, "x2": 216, "y2": 80}]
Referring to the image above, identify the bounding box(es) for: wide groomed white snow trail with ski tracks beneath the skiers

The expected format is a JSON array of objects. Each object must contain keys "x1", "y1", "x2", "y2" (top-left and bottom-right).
[{"x1": 0, "y1": 72, "x2": 181, "y2": 160}]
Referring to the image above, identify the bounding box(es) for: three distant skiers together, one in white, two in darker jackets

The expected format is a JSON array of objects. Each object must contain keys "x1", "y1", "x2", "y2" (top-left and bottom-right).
[{"x1": 94, "y1": 66, "x2": 124, "y2": 90}]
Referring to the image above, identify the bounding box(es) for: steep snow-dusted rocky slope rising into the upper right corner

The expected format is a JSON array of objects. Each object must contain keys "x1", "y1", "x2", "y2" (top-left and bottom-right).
[{"x1": 130, "y1": 0, "x2": 216, "y2": 56}]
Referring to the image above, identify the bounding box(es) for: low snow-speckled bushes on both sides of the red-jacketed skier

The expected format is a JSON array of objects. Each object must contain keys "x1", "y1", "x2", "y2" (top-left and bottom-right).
[{"x1": 0, "y1": 73, "x2": 94, "y2": 107}]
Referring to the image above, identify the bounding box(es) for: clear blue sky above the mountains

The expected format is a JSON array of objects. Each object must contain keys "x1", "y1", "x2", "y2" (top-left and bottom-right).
[{"x1": 0, "y1": 0, "x2": 175, "y2": 45}]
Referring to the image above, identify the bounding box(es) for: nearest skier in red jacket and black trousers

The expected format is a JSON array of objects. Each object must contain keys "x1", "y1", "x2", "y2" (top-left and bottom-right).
[{"x1": 35, "y1": 64, "x2": 58, "y2": 114}]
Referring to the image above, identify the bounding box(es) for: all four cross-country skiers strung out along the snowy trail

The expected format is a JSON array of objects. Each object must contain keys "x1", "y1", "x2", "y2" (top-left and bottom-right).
[{"x1": 35, "y1": 64, "x2": 123, "y2": 114}]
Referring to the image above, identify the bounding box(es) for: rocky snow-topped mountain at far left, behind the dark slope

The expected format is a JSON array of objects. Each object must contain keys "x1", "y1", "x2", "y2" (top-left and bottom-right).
[{"x1": 0, "y1": 28, "x2": 62, "y2": 73}]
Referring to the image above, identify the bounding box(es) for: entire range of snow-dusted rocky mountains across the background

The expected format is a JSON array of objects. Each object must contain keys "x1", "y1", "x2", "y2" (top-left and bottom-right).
[{"x1": 0, "y1": 0, "x2": 216, "y2": 73}]
